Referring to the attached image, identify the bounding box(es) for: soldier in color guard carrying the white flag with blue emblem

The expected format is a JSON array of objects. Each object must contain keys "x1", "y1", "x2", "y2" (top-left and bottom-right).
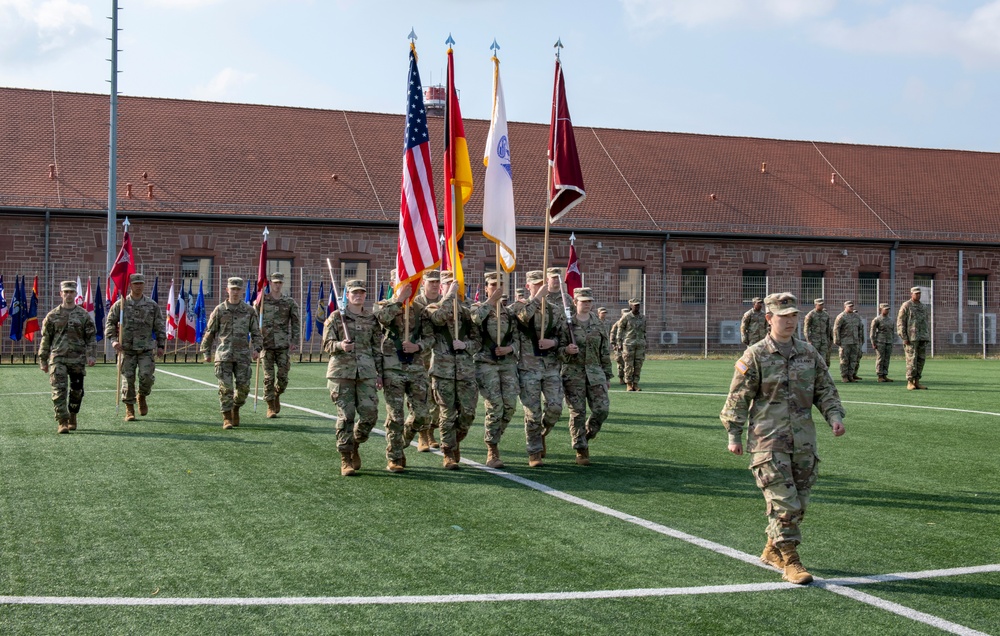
[{"x1": 471, "y1": 272, "x2": 520, "y2": 468}]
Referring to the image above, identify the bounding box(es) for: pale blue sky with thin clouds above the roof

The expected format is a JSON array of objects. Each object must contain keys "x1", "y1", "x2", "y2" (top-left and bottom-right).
[{"x1": 0, "y1": 0, "x2": 1000, "y2": 152}]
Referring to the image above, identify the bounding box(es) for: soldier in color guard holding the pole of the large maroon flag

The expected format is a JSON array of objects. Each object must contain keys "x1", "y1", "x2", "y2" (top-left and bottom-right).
[{"x1": 514, "y1": 270, "x2": 566, "y2": 468}]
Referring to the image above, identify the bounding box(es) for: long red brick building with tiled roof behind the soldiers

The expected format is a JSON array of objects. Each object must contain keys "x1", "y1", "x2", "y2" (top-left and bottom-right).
[{"x1": 0, "y1": 88, "x2": 1000, "y2": 351}]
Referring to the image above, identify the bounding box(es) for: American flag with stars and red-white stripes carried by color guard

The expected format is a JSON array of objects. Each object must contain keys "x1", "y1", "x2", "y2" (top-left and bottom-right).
[{"x1": 396, "y1": 45, "x2": 441, "y2": 298}]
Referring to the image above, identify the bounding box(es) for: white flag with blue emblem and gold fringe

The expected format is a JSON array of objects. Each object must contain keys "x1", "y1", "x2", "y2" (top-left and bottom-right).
[{"x1": 483, "y1": 57, "x2": 517, "y2": 273}]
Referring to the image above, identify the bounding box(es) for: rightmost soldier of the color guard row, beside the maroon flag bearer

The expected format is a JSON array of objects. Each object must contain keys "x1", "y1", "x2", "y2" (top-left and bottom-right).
[{"x1": 559, "y1": 287, "x2": 612, "y2": 466}]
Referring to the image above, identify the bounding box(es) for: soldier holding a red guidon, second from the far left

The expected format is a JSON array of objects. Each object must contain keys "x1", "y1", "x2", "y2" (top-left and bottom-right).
[{"x1": 104, "y1": 274, "x2": 167, "y2": 422}]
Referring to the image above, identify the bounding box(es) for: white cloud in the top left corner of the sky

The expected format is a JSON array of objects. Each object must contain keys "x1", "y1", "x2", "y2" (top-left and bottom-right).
[{"x1": 0, "y1": 0, "x2": 101, "y2": 64}]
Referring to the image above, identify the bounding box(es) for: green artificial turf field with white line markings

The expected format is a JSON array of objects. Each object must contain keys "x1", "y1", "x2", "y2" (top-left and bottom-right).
[{"x1": 0, "y1": 358, "x2": 1000, "y2": 635}]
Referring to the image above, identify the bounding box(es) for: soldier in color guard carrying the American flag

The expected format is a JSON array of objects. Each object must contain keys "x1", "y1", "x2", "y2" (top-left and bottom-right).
[{"x1": 373, "y1": 270, "x2": 434, "y2": 467}]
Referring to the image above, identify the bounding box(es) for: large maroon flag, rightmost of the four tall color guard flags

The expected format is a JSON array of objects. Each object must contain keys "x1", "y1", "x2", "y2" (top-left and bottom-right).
[{"x1": 549, "y1": 57, "x2": 587, "y2": 223}]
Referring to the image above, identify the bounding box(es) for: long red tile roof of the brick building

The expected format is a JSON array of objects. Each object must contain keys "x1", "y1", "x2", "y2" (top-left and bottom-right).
[{"x1": 0, "y1": 88, "x2": 1000, "y2": 243}]
